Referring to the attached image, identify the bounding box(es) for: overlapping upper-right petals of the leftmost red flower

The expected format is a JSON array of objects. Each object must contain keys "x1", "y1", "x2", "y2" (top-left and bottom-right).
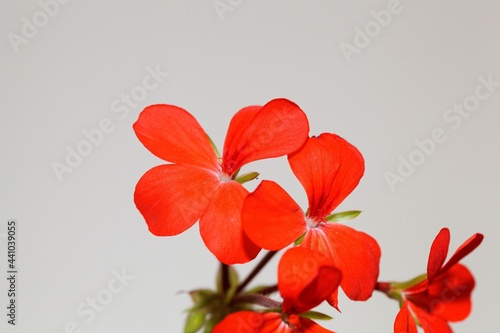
[{"x1": 222, "y1": 99, "x2": 309, "y2": 175}]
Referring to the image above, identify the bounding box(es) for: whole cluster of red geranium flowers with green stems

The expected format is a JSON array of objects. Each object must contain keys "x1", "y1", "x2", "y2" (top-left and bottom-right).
[{"x1": 134, "y1": 99, "x2": 483, "y2": 333}]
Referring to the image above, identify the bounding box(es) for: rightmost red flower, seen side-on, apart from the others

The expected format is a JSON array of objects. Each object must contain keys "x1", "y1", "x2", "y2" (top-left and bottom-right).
[{"x1": 392, "y1": 228, "x2": 484, "y2": 333}]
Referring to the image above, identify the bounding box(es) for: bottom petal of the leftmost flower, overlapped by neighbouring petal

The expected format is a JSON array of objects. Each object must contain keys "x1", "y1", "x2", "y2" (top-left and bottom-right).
[{"x1": 200, "y1": 181, "x2": 260, "y2": 265}]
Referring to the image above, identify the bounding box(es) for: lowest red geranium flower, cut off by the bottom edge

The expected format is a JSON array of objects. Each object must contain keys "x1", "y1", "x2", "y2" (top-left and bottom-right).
[{"x1": 212, "y1": 247, "x2": 341, "y2": 333}]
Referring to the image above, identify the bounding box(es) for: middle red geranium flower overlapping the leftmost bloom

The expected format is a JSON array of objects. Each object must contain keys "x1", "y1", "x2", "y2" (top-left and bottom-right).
[{"x1": 242, "y1": 133, "x2": 380, "y2": 300}]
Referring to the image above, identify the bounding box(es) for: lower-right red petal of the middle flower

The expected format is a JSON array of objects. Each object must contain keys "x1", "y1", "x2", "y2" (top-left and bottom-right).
[{"x1": 301, "y1": 223, "x2": 381, "y2": 301}]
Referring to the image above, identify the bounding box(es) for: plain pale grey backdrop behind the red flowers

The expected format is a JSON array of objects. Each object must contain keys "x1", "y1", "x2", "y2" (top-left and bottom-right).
[{"x1": 0, "y1": 0, "x2": 500, "y2": 333}]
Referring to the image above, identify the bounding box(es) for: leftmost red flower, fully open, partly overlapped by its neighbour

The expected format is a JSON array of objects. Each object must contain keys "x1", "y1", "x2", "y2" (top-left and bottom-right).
[{"x1": 134, "y1": 99, "x2": 309, "y2": 264}]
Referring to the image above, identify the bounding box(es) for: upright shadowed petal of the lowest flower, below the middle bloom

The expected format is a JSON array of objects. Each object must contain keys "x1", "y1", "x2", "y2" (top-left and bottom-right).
[{"x1": 278, "y1": 247, "x2": 341, "y2": 314}]
